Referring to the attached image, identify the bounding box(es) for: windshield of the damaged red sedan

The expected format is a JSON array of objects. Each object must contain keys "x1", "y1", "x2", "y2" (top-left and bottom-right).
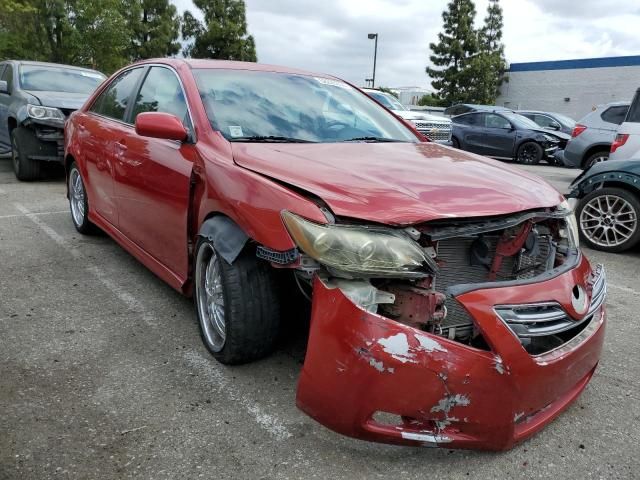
[{"x1": 193, "y1": 69, "x2": 418, "y2": 142}]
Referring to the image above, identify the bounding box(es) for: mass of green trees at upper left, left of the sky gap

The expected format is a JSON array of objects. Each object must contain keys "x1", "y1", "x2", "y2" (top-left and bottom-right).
[{"x1": 0, "y1": 0, "x2": 180, "y2": 73}]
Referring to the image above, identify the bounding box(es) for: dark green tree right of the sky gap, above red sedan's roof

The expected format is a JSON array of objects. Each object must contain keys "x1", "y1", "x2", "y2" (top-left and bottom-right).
[{"x1": 182, "y1": 0, "x2": 257, "y2": 62}]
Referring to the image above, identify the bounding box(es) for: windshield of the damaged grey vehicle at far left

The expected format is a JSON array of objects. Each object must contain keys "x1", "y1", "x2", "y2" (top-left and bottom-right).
[{"x1": 20, "y1": 65, "x2": 106, "y2": 95}]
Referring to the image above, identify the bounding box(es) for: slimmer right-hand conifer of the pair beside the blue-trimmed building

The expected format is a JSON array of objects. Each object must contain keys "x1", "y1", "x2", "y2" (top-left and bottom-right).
[{"x1": 473, "y1": 0, "x2": 507, "y2": 104}]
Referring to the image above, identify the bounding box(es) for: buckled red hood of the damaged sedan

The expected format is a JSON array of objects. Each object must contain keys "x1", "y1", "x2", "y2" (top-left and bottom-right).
[{"x1": 233, "y1": 143, "x2": 562, "y2": 225}]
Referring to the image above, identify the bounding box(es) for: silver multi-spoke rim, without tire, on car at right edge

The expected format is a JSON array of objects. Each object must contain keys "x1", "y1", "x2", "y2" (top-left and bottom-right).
[{"x1": 580, "y1": 195, "x2": 638, "y2": 247}]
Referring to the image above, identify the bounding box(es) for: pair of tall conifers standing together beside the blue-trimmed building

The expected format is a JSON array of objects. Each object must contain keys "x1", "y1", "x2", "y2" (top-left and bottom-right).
[{"x1": 427, "y1": 0, "x2": 506, "y2": 105}]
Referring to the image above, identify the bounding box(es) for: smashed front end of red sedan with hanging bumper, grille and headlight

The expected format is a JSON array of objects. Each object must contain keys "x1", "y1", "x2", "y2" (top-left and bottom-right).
[{"x1": 276, "y1": 204, "x2": 606, "y2": 450}]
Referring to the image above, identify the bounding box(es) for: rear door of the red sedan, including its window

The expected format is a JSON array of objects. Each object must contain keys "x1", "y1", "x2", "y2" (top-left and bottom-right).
[{"x1": 81, "y1": 67, "x2": 145, "y2": 226}]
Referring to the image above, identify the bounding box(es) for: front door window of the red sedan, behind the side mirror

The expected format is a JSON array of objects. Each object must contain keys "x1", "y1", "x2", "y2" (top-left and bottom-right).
[{"x1": 133, "y1": 67, "x2": 188, "y2": 125}]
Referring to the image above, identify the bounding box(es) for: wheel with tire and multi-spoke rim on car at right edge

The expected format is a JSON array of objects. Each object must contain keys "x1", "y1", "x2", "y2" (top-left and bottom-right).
[{"x1": 576, "y1": 188, "x2": 640, "y2": 253}]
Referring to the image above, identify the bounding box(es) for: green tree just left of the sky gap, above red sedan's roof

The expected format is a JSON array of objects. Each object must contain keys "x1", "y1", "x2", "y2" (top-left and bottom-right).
[{"x1": 124, "y1": 0, "x2": 180, "y2": 61}]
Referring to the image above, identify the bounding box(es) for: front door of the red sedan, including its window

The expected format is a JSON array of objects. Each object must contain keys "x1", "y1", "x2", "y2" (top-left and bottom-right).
[{"x1": 115, "y1": 66, "x2": 196, "y2": 279}]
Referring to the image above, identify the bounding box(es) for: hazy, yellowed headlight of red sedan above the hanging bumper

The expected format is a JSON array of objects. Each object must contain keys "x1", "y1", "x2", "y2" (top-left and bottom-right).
[{"x1": 282, "y1": 211, "x2": 437, "y2": 278}]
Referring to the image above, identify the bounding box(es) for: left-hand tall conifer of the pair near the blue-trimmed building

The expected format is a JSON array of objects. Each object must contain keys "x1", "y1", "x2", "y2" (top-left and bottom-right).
[{"x1": 426, "y1": 0, "x2": 479, "y2": 104}]
